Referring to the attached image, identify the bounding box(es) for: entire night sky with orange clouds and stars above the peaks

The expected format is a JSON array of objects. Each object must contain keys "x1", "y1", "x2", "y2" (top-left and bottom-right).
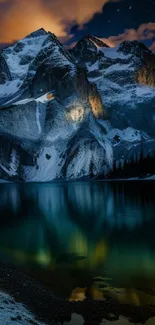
[{"x1": 0, "y1": 0, "x2": 155, "y2": 50}]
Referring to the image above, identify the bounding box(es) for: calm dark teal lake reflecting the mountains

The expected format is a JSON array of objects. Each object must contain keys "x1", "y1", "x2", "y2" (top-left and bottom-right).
[{"x1": 0, "y1": 181, "x2": 155, "y2": 304}]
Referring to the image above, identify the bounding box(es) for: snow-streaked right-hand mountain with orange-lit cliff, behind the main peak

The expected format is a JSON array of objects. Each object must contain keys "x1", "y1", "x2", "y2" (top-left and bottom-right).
[{"x1": 72, "y1": 41, "x2": 155, "y2": 136}]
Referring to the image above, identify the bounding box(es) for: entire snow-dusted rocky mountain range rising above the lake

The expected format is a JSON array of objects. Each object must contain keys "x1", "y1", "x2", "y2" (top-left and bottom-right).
[{"x1": 0, "y1": 29, "x2": 155, "y2": 181}]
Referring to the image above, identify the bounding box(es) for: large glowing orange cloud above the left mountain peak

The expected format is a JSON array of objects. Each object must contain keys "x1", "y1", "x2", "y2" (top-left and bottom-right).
[{"x1": 0, "y1": 0, "x2": 119, "y2": 43}]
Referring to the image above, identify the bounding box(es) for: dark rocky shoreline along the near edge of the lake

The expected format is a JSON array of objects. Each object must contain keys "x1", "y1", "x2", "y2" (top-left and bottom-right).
[{"x1": 0, "y1": 265, "x2": 155, "y2": 325}]
